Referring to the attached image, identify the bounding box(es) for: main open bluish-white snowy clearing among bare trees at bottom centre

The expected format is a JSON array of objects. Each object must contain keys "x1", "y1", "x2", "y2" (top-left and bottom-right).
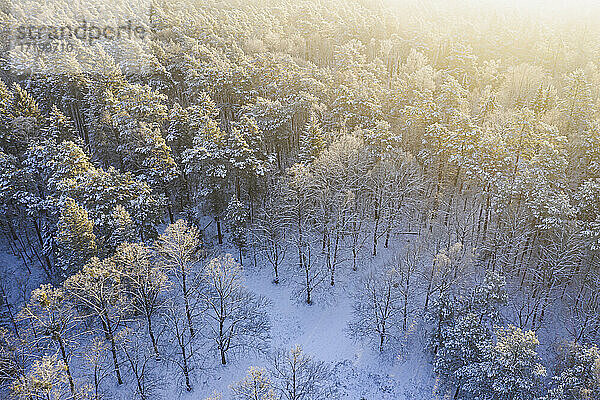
[{"x1": 178, "y1": 271, "x2": 433, "y2": 400}]
